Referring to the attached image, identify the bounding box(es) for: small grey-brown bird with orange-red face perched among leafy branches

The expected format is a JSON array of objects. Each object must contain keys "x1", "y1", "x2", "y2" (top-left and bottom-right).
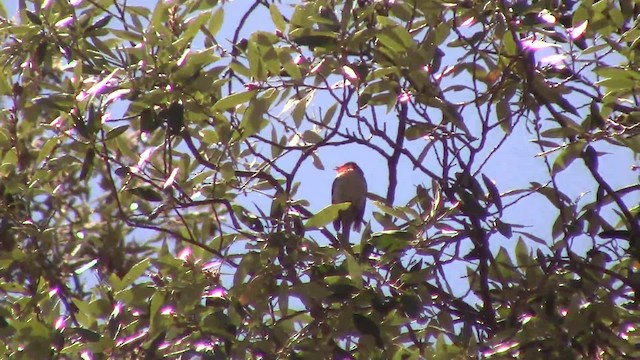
[{"x1": 331, "y1": 161, "x2": 367, "y2": 235}]
